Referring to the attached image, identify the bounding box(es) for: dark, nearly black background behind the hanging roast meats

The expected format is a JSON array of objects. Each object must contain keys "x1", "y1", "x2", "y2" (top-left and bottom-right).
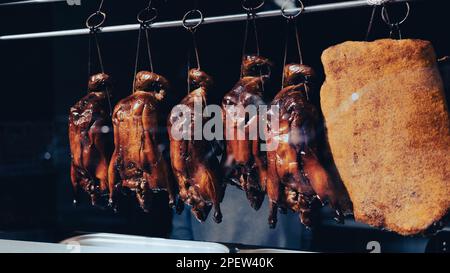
[{"x1": 0, "y1": 0, "x2": 450, "y2": 251}]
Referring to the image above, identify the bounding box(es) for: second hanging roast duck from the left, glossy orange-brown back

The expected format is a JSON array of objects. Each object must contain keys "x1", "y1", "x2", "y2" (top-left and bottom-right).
[{"x1": 109, "y1": 71, "x2": 176, "y2": 212}]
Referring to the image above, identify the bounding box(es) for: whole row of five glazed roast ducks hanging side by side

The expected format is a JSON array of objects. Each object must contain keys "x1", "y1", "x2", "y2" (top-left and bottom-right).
[{"x1": 69, "y1": 55, "x2": 348, "y2": 227}]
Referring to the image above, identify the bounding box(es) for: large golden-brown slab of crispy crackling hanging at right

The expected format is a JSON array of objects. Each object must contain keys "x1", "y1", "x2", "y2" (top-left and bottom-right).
[{"x1": 321, "y1": 39, "x2": 450, "y2": 235}]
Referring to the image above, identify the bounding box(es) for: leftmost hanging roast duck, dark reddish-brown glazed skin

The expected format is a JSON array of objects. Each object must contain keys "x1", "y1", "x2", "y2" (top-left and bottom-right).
[{"x1": 69, "y1": 74, "x2": 114, "y2": 206}]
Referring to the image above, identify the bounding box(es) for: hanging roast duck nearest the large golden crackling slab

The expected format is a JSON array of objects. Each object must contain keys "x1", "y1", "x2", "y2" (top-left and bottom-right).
[{"x1": 267, "y1": 64, "x2": 340, "y2": 228}]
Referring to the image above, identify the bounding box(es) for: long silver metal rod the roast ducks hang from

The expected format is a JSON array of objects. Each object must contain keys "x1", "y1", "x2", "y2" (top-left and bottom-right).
[{"x1": 0, "y1": 0, "x2": 418, "y2": 40}]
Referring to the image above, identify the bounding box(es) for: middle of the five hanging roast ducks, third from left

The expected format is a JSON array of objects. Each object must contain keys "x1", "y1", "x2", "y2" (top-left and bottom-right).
[{"x1": 167, "y1": 69, "x2": 225, "y2": 223}]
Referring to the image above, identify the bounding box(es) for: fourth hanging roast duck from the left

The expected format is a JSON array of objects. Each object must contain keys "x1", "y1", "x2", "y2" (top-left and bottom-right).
[{"x1": 222, "y1": 55, "x2": 271, "y2": 210}]
